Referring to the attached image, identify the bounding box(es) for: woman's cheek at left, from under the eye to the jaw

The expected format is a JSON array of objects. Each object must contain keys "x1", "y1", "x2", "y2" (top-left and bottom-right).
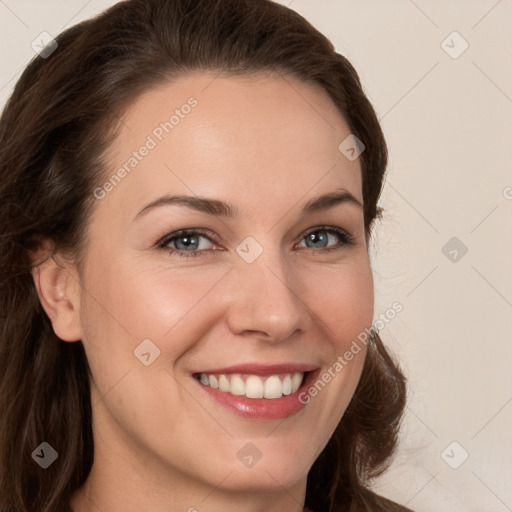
[{"x1": 76, "y1": 251, "x2": 229, "y2": 439}]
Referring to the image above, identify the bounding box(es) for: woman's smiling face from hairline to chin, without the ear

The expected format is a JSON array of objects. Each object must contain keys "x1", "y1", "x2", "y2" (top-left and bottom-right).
[{"x1": 70, "y1": 73, "x2": 373, "y2": 504}]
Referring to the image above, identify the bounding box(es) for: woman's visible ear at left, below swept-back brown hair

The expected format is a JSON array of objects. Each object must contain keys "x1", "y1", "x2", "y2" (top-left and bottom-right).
[{"x1": 32, "y1": 245, "x2": 82, "y2": 341}]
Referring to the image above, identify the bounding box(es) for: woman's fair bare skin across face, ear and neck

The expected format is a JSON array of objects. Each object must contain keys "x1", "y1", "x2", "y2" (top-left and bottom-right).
[{"x1": 34, "y1": 72, "x2": 373, "y2": 512}]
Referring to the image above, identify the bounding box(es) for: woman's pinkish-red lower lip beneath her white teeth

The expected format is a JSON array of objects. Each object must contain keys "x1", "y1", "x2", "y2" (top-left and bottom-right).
[{"x1": 192, "y1": 370, "x2": 320, "y2": 420}]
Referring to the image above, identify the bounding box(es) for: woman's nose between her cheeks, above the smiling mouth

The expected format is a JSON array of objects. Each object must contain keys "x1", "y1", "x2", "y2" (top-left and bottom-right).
[{"x1": 227, "y1": 251, "x2": 307, "y2": 343}]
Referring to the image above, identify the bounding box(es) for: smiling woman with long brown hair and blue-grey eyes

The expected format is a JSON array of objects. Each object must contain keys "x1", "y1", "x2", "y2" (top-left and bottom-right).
[{"x1": 0, "y1": 0, "x2": 407, "y2": 512}]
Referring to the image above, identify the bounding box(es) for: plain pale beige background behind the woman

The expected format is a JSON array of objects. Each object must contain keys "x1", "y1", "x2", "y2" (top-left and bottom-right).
[{"x1": 0, "y1": 0, "x2": 512, "y2": 512}]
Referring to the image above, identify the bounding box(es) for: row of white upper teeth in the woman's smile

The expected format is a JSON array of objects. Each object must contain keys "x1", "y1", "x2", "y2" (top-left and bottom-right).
[{"x1": 199, "y1": 372, "x2": 304, "y2": 398}]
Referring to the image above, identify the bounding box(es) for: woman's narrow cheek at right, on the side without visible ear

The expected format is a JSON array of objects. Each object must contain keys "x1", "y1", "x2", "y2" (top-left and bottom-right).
[{"x1": 302, "y1": 257, "x2": 374, "y2": 424}]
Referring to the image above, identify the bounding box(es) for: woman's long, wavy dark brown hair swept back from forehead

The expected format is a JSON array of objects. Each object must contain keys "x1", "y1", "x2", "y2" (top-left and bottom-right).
[{"x1": 0, "y1": 0, "x2": 406, "y2": 512}]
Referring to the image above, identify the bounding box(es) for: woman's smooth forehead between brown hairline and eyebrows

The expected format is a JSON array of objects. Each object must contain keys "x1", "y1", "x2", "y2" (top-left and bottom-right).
[{"x1": 96, "y1": 72, "x2": 362, "y2": 222}]
